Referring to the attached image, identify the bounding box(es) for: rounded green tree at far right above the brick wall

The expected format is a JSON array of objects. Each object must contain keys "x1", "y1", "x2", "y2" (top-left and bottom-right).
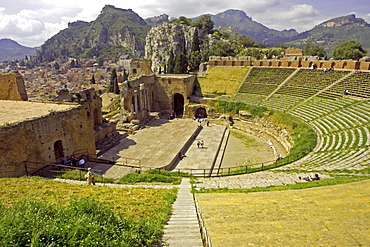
[{"x1": 333, "y1": 40, "x2": 366, "y2": 60}]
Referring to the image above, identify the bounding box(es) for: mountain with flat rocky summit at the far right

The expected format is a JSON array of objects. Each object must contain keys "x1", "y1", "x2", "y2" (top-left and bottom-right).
[{"x1": 286, "y1": 14, "x2": 370, "y2": 55}]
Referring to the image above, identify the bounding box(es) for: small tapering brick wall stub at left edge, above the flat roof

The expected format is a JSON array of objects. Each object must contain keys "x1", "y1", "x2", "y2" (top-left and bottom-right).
[{"x1": 0, "y1": 72, "x2": 28, "y2": 100}]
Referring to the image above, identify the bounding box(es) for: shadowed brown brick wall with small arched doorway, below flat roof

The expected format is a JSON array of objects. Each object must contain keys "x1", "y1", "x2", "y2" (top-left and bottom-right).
[{"x1": 0, "y1": 106, "x2": 96, "y2": 177}]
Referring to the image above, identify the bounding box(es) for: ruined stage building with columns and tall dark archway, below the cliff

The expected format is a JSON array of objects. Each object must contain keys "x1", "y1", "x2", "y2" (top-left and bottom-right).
[{"x1": 121, "y1": 59, "x2": 195, "y2": 121}]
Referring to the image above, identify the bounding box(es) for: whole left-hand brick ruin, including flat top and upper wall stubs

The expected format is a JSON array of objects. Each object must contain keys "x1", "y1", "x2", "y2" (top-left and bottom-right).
[{"x1": 0, "y1": 73, "x2": 110, "y2": 177}]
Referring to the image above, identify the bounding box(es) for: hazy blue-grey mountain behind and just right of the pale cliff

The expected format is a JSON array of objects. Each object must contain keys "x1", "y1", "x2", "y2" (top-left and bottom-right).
[{"x1": 193, "y1": 9, "x2": 298, "y2": 46}]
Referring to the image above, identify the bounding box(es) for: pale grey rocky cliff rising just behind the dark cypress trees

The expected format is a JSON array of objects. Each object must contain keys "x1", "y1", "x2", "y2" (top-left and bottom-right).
[{"x1": 145, "y1": 22, "x2": 214, "y2": 72}]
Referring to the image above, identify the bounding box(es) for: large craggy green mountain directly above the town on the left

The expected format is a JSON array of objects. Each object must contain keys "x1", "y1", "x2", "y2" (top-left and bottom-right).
[{"x1": 40, "y1": 5, "x2": 150, "y2": 62}]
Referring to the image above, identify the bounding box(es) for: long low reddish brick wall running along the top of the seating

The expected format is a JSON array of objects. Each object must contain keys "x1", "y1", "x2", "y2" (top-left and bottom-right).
[{"x1": 208, "y1": 49, "x2": 370, "y2": 70}]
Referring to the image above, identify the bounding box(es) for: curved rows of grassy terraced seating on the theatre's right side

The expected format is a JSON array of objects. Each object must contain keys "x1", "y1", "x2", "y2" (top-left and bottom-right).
[{"x1": 210, "y1": 67, "x2": 370, "y2": 173}]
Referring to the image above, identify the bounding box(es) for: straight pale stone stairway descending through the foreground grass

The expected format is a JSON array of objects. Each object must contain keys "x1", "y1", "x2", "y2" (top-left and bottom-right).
[{"x1": 163, "y1": 178, "x2": 203, "y2": 247}]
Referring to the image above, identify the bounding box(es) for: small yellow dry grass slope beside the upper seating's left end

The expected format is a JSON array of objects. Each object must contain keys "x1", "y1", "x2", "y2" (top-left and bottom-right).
[{"x1": 198, "y1": 67, "x2": 249, "y2": 95}]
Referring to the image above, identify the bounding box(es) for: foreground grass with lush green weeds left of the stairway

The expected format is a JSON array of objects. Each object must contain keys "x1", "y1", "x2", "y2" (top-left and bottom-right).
[{"x1": 0, "y1": 178, "x2": 177, "y2": 246}]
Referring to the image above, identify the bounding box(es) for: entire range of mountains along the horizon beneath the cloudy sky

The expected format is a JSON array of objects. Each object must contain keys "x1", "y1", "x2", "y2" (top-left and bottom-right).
[{"x1": 0, "y1": 5, "x2": 370, "y2": 61}]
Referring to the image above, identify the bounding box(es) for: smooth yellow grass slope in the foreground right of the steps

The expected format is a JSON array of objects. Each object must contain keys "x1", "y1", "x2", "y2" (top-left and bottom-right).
[{"x1": 197, "y1": 180, "x2": 370, "y2": 247}]
